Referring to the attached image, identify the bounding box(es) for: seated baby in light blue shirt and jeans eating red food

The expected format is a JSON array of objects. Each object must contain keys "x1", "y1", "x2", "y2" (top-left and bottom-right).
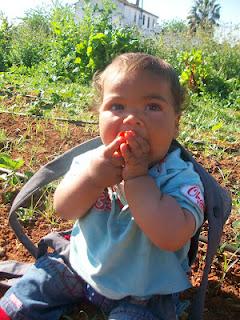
[{"x1": 0, "y1": 53, "x2": 204, "y2": 320}]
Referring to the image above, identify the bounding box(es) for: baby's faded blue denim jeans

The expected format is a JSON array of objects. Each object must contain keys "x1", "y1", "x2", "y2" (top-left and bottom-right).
[{"x1": 0, "y1": 253, "x2": 181, "y2": 320}]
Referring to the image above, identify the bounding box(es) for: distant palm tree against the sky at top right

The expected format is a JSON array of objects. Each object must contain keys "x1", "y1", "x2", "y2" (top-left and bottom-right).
[{"x1": 187, "y1": 0, "x2": 221, "y2": 32}]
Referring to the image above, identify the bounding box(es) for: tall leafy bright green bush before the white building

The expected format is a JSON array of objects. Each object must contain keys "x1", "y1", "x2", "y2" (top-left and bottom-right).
[{"x1": 42, "y1": 0, "x2": 147, "y2": 83}]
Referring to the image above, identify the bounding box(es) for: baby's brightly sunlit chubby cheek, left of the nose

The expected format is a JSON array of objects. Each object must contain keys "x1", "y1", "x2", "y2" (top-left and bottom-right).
[{"x1": 99, "y1": 113, "x2": 121, "y2": 145}]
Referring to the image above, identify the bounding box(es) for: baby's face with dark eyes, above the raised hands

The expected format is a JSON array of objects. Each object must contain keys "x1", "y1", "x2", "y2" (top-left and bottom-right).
[{"x1": 99, "y1": 71, "x2": 179, "y2": 164}]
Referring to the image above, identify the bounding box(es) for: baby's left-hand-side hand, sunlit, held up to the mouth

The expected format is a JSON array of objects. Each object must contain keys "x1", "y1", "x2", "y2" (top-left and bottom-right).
[{"x1": 89, "y1": 137, "x2": 124, "y2": 188}]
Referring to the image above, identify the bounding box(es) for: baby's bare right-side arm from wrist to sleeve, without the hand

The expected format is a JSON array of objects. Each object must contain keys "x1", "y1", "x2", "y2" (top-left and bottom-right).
[{"x1": 124, "y1": 175, "x2": 195, "y2": 251}]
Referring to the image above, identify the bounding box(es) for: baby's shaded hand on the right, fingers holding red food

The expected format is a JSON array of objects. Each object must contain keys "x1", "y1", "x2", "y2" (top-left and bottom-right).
[{"x1": 119, "y1": 130, "x2": 150, "y2": 180}]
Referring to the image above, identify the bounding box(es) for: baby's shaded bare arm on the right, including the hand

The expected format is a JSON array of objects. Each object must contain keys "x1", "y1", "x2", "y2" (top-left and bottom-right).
[{"x1": 120, "y1": 135, "x2": 195, "y2": 251}]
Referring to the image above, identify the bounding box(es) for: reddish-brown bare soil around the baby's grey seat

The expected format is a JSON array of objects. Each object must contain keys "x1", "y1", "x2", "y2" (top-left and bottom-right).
[{"x1": 0, "y1": 114, "x2": 240, "y2": 320}]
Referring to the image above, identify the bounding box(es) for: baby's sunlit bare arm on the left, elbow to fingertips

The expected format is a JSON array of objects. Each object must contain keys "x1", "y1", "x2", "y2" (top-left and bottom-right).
[{"x1": 54, "y1": 138, "x2": 123, "y2": 219}]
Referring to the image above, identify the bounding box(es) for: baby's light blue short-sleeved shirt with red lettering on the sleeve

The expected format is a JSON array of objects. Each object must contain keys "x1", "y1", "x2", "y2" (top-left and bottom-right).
[{"x1": 65, "y1": 147, "x2": 204, "y2": 299}]
